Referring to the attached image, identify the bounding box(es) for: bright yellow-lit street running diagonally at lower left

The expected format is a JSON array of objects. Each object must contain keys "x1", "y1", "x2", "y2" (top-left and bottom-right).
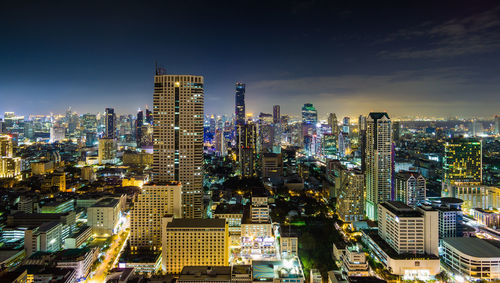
[{"x1": 88, "y1": 230, "x2": 130, "y2": 283}]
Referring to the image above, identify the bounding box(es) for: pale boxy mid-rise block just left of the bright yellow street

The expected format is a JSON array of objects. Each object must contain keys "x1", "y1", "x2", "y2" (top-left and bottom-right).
[{"x1": 87, "y1": 198, "x2": 121, "y2": 236}]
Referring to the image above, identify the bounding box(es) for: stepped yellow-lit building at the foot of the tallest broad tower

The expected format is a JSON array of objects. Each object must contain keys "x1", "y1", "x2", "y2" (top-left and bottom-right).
[{"x1": 130, "y1": 182, "x2": 182, "y2": 252}]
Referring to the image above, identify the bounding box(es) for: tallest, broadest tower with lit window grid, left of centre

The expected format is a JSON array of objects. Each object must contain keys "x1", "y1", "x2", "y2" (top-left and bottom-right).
[{"x1": 153, "y1": 70, "x2": 204, "y2": 218}]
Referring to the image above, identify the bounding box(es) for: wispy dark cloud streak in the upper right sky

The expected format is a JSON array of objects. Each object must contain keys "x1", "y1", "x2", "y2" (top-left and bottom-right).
[{"x1": 379, "y1": 7, "x2": 500, "y2": 59}]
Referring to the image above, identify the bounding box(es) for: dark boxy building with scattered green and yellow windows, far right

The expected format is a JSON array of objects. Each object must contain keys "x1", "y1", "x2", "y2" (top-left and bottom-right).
[{"x1": 443, "y1": 139, "x2": 483, "y2": 186}]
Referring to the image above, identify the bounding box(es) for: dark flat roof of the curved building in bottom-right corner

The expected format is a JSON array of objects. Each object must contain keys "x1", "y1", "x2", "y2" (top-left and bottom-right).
[{"x1": 443, "y1": 237, "x2": 500, "y2": 258}]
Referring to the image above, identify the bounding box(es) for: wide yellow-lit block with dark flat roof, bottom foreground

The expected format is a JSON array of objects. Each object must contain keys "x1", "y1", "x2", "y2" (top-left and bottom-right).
[{"x1": 162, "y1": 218, "x2": 229, "y2": 274}]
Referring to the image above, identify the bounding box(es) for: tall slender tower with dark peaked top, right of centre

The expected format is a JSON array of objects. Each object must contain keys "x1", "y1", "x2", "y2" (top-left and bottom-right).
[{"x1": 365, "y1": 112, "x2": 393, "y2": 220}]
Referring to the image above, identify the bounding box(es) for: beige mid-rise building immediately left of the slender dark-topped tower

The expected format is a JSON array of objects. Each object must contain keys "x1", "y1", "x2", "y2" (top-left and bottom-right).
[{"x1": 335, "y1": 166, "x2": 365, "y2": 222}]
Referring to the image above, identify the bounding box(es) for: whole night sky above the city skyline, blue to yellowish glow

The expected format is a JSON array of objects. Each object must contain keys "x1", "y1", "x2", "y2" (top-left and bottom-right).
[{"x1": 0, "y1": 0, "x2": 500, "y2": 117}]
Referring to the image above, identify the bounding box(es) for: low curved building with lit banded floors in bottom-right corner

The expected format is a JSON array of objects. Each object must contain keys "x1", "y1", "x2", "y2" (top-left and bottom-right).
[{"x1": 441, "y1": 240, "x2": 500, "y2": 281}]
